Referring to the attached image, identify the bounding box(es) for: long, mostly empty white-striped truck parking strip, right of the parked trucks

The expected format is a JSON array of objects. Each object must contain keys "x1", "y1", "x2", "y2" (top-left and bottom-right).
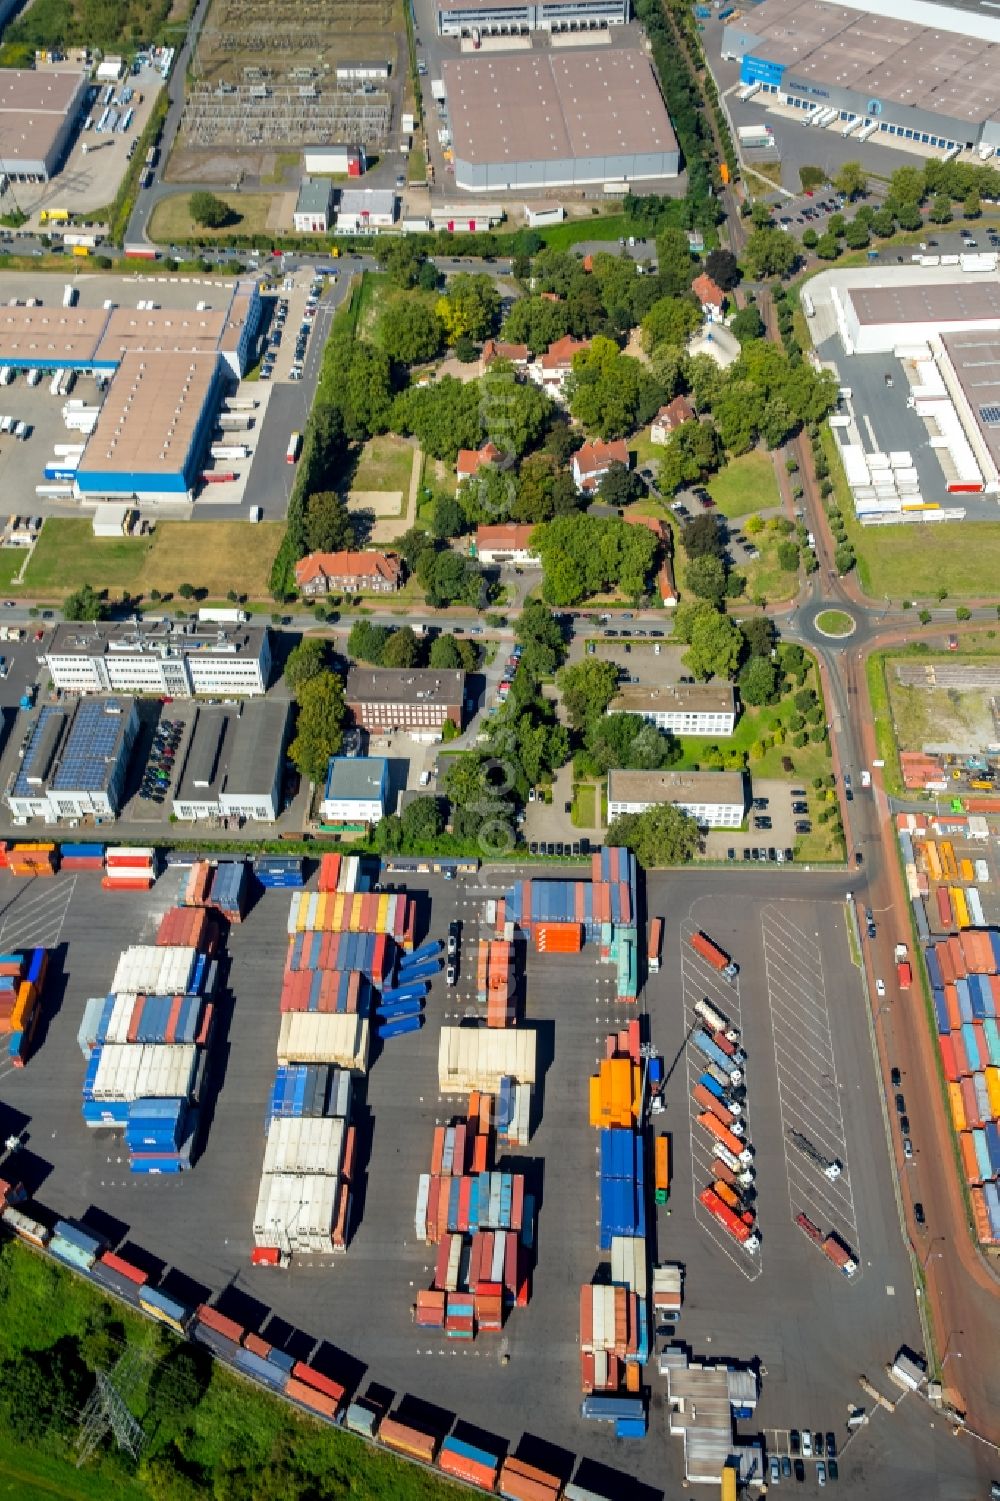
[{"x1": 761, "y1": 907, "x2": 862, "y2": 1282}]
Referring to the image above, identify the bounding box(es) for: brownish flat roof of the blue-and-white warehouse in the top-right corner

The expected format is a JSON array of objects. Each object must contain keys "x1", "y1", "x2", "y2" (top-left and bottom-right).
[{"x1": 731, "y1": 0, "x2": 1000, "y2": 122}]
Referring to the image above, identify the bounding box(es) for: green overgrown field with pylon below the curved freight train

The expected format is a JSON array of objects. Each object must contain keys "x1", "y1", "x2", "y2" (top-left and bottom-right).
[{"x1": 0, "y1": 1243, "x2": 461, "y2": 1501}]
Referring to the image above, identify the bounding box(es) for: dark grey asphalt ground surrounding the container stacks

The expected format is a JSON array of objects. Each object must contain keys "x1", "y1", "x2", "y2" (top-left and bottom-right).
[{"x1": 0, "y1": 869, "x2": 971, "y2": 1498}]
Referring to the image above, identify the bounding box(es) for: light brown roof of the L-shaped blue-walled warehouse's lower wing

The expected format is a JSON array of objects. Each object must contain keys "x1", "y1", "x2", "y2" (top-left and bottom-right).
[{"x1": 80, "y1": 353, "x2": 219, "y2": 474}]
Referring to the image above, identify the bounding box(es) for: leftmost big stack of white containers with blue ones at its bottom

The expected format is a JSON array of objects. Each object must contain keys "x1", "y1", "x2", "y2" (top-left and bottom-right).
[{"x1": 78, "y1": 907, "x2": 219, "y2": 1174}]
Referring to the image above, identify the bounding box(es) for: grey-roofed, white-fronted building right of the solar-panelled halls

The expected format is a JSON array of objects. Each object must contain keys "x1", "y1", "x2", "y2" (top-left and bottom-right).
[{"x1": 173, "y1": 698, "x2": 291, "y2": 824}]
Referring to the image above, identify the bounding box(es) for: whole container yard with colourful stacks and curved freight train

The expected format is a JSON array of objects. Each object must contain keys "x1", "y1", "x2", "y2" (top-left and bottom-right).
[{"x1": 0, "y1": 845, "x2": 960, "y2": 1501}]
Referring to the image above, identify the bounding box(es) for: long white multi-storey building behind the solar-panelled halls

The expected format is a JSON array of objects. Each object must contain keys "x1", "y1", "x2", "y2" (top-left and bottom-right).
[{"x1": 45, "y1": 620, "x2": 270, "y2": 698}]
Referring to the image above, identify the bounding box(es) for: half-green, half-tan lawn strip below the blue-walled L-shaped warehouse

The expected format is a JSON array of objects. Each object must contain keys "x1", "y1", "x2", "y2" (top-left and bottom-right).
[{"x1": 24, "y1": 518, "x2": 284, "y2": 603}]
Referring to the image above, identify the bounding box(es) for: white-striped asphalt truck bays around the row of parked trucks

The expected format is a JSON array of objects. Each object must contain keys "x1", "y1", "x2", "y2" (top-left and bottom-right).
[{"x1": 680, "y1": 922, "x2": 764, "y2": 1282}]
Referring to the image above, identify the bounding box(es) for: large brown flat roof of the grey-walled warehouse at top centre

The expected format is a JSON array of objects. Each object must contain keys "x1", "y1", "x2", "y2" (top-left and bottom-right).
[{"x1": 443, "y1": 47, "x2": 677, "y2": 162}]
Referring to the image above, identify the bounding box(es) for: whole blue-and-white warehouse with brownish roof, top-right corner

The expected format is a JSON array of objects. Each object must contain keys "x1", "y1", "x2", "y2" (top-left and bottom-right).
[{"x1": 722, "y1": 0, "x2": 1000, "y2": 159}]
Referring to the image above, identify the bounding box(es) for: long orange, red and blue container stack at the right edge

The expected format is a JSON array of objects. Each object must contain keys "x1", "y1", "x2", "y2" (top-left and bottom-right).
[{"x1": 923, "y1": 929, "x2": 1000, "y2": 1246}]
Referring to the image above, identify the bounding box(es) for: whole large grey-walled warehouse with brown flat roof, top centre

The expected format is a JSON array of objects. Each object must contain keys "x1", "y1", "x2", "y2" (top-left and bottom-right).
[{"x1": 441, "y1": 47, "x2": 679, "y2": 192}]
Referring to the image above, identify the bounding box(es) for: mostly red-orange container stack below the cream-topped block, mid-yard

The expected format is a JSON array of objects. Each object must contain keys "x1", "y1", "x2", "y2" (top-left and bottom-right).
[{"x1": 414, "y1": 1093, "x2": 535, "y2": 1339}]
